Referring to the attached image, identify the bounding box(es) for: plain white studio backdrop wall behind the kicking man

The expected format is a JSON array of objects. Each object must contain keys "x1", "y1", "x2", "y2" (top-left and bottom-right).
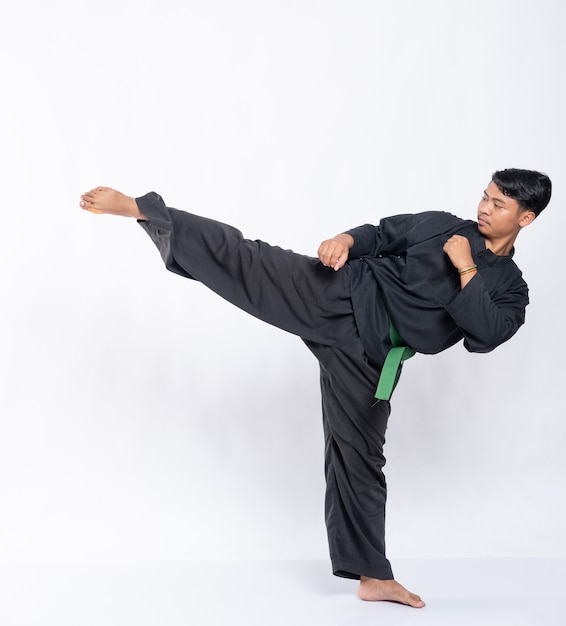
[{"x1": 0, "y1": 0, "x2": 566, "y2": 563}]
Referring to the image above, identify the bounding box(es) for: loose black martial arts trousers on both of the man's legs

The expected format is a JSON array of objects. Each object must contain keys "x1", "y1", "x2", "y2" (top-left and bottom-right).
[{"x1": 137, "y1": 193, "x2": 393, "y2": 579}]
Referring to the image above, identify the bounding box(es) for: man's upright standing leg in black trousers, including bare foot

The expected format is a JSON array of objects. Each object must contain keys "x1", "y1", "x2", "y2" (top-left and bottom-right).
[{"x1": 306, "y1": 326, "x2": 424, "y2": 608}]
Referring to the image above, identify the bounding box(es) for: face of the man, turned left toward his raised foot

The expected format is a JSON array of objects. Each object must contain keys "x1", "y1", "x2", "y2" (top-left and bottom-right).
[{"x1": 478, "y1": 181, "x2": 535, "y2": 241}]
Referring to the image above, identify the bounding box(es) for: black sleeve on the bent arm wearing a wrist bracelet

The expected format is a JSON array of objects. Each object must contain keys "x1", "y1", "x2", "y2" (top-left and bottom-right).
[{"x1": 445, "y1": 272, "x2": 529, "y2": 352}]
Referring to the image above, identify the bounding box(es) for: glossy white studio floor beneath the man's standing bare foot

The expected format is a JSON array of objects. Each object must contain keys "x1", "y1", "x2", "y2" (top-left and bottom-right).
[{"x1": 0, "y1": 559, "x2": 566, "y2": 626}]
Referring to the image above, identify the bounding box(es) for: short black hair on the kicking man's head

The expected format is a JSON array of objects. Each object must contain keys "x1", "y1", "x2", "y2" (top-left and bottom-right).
[{"x1": 491, "y1": 168, "x2": 552, "y2": 216}]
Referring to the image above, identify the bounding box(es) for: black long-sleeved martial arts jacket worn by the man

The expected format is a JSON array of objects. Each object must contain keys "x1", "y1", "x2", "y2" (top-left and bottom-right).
[{"x1": 348, "y1": 211, "x2": 529, "y2": 363}]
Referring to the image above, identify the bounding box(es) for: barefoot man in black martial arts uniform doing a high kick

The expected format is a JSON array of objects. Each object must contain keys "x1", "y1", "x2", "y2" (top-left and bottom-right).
[{"x1": 80, "y1": 169, "x2": 551, "y2": 608}]
